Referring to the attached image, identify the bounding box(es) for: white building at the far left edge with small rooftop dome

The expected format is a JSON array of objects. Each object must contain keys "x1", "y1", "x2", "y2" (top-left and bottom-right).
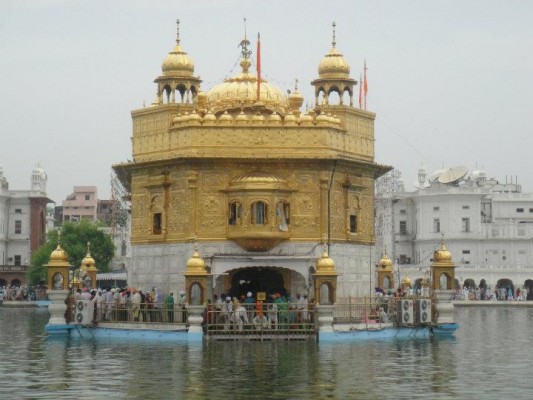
[{"x1": 0, "y1": 166, "x2": 52, "y2": 286}]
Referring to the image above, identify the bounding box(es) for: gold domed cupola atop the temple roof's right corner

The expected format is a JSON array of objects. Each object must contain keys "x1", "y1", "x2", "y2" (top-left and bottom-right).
[{"x1": 311, "y1": 22, "x2": 357, "y2": 108}]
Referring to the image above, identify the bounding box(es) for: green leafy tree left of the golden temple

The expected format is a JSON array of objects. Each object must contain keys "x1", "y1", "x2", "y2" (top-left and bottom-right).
[{"x1": 27, "y1": 219, "x2": 115, "y2": 284}]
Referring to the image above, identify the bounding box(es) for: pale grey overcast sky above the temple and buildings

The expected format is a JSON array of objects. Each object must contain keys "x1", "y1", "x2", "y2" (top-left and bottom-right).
[{"x1": 0, "y1": 0, "x2": 533, "y2": 204}]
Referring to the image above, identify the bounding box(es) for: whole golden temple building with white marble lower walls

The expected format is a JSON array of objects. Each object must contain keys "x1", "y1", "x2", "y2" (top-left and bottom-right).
[{"x1": 113, "y1": 21, "x2": 390, "y2": 303}]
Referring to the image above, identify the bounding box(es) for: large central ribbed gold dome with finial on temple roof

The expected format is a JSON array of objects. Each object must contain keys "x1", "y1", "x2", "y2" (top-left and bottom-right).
[{"x1": 207, "y1": 34, "x2": 289, "y2": 113}]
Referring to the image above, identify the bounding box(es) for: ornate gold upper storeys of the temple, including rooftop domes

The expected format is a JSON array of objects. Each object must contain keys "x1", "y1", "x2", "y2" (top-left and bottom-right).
[{"x1": 114, "y1": 21, "x2": 389, "y2": 258}]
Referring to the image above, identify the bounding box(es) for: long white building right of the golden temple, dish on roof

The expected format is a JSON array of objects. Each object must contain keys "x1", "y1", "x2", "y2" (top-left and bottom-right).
[{"x1": 376, "y1": 167, "x2": 533, "y2": 287}]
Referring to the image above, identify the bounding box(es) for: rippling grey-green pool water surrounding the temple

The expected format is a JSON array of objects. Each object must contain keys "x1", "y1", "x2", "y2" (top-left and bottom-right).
[{"x1": 0, "y1": 308, "x2": 533, "y2": 399}]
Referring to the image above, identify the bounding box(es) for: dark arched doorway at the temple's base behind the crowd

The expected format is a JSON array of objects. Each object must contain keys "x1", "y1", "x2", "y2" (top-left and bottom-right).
[{"x1": 229, "y1": 267, "x2": 287, "y2": 298}]
